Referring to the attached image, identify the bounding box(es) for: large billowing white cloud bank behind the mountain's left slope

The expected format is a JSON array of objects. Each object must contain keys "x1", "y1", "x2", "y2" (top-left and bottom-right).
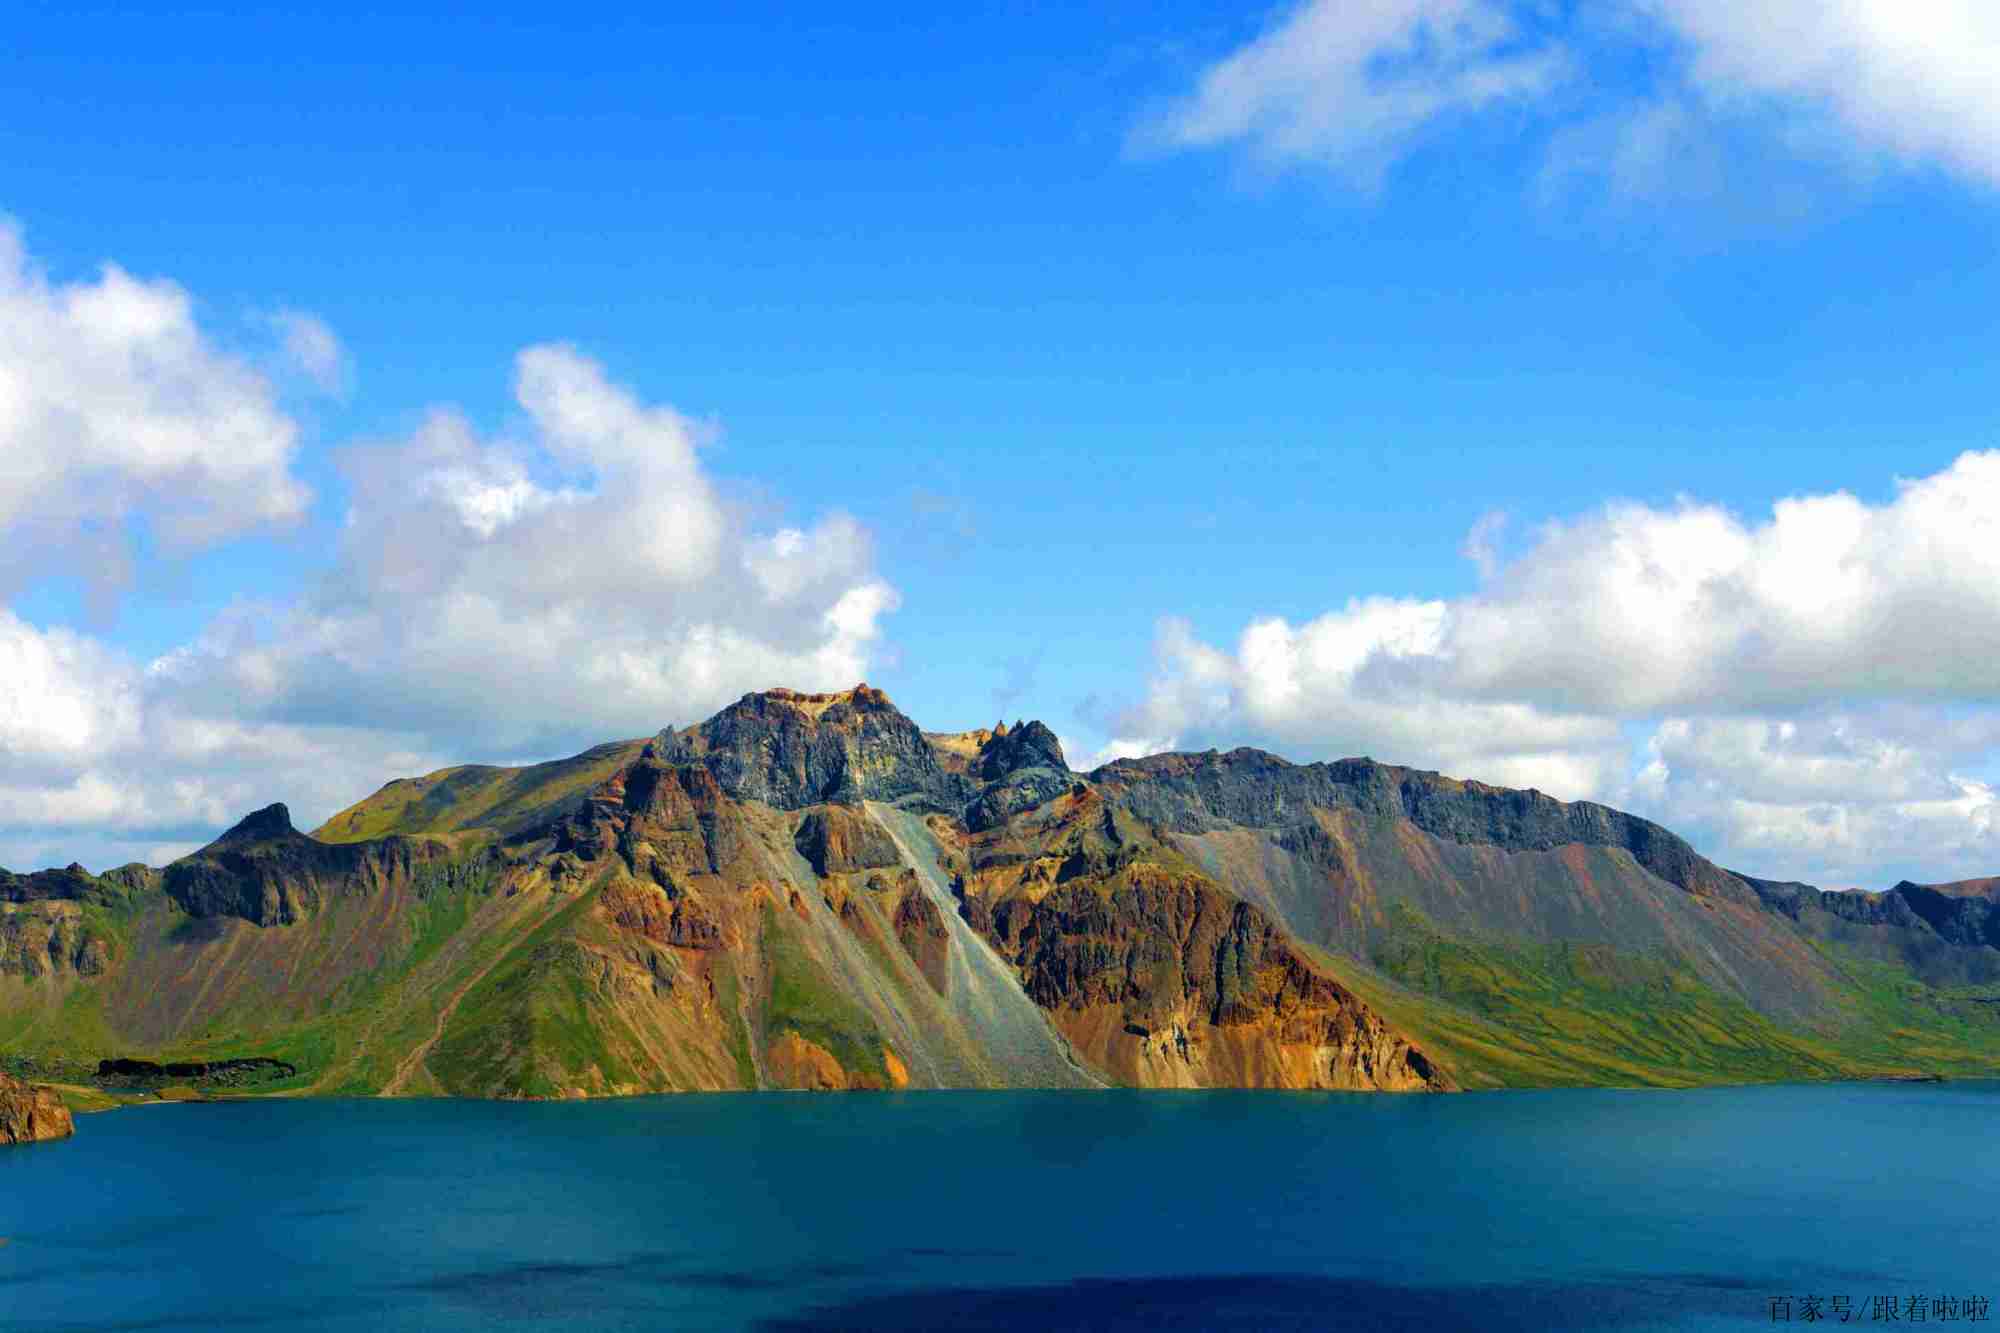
[{"x1": 0, "y1": 334, "x2": 896, "y2": 865}]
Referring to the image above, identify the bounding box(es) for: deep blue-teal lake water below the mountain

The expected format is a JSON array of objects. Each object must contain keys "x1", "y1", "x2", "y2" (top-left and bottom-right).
[{"x1": 0, "y1": 1083, "x2": 2000, "y2": 1333}]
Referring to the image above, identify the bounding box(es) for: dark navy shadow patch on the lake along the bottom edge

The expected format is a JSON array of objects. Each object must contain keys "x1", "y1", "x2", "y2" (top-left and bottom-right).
[{"x1": 756, "y1": 1273, "x2": 1856, "y2": 1333}]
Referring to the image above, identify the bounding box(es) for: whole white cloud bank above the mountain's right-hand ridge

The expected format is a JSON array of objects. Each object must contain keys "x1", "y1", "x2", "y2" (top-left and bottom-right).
[{"x1": 1112, "y1": 452, "x2": 2000, "y2": 881}]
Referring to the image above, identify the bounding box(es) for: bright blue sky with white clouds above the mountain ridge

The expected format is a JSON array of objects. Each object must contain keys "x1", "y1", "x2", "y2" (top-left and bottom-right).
[{"x1": 0, "y1": 0, "x2": 2000, "y2": 889}]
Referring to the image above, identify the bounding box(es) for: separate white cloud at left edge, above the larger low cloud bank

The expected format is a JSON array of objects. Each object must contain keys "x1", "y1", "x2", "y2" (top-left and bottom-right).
[{"x1": 0, "y1": 220, "x2": 310, "y2": 594}]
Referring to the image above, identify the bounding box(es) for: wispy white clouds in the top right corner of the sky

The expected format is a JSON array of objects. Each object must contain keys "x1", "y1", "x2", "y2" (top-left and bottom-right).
[{"x1": 1140, "y1": 0, "x2": 2000, "y2": 192}]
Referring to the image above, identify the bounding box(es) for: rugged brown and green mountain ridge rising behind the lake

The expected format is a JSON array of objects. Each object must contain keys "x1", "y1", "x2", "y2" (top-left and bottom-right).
[{"x1": 0, "y1": 685, "x2": 2000, "y2": 1097}]
